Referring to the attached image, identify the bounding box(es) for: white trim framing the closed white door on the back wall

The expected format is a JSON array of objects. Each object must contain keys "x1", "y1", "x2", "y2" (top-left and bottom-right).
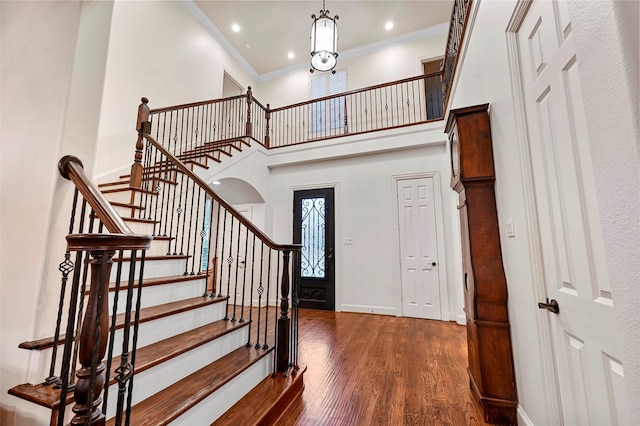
[{"x1": 391, "y1": 171, "x2": 448, "y2": 321}]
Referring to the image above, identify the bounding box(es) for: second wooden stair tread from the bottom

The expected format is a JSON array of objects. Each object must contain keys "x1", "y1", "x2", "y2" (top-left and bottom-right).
[{"x1": 107, "y1": 346, "x2": 272, "y2": 426}]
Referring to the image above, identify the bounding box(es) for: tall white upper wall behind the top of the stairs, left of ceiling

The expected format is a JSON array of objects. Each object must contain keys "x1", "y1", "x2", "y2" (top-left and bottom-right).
[{"x1": 95, "y1": 1, "x2": 256, "y2": 177}]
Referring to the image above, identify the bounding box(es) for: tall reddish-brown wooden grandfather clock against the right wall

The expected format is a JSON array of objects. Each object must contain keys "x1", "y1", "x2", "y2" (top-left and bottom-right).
[{"x1": 445, "y1": 104, "x2": 518, "y2": 425}]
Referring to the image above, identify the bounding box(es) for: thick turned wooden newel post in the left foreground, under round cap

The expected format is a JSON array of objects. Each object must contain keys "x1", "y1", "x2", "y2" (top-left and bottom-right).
[{"x1": 71, "y1": 250, "x2": 116, "y2": 426}]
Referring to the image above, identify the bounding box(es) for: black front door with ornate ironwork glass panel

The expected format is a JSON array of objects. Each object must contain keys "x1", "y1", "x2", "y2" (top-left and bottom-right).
[{"x1": 293, "y1": 188, "x2": 335, "y2": 311}]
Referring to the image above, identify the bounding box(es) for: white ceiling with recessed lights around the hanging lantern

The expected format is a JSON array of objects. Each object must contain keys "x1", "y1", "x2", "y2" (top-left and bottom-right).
[{"x1": 190, "y1": 0, "x2": 453, "y2": 75}]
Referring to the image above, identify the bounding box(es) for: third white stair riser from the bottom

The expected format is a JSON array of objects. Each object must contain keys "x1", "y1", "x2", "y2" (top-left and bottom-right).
[{"x1": 23, "y1": 303, "x2": 229, "y2": 383}]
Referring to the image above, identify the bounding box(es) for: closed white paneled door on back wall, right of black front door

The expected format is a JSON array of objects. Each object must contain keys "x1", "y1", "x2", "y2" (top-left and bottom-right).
[{"x1": 397, "y1": 178, "x2": 442, "y2": 320}]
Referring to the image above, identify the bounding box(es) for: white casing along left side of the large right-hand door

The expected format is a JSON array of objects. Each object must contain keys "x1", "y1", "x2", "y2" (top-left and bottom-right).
[{"x1": 505, "y1": 0, "x2": 562, "y2": 424}]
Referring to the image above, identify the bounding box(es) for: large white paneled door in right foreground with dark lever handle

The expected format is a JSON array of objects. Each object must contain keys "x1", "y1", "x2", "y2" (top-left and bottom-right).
[{"x1": 517, "y1": 1, "x2": 631, "y2": 425}]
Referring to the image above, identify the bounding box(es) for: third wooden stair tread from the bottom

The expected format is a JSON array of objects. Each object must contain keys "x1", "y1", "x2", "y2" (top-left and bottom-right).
[{"x1": 9, "y1": 320, "x2": 249, "y2": 408}]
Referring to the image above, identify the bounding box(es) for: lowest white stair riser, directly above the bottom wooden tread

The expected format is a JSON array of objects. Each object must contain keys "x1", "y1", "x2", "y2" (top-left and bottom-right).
[{"x1": 169, "y1": 353, "x2": 273, "y2": 426}]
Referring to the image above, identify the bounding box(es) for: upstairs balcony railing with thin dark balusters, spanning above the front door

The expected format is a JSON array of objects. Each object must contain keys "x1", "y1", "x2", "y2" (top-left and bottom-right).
[{"x1": 138, "y1": 73, "x2": 444, "y2": 163}]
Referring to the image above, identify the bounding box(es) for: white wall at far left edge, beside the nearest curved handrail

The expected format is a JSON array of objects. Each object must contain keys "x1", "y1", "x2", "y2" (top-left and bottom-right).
[{"x1": 0, "y1": 1, "x2": 82, "y2": 425}]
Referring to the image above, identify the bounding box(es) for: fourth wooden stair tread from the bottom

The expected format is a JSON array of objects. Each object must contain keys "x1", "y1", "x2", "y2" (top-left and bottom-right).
[{"x1": 18, "y1": 296, "x2": 227, "y2": 350}]
